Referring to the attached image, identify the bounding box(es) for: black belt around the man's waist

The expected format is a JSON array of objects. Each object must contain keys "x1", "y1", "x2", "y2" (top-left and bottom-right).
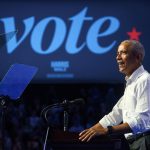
[{"x1": 127, "y1": 131, "x2": 150, "y2": 143}]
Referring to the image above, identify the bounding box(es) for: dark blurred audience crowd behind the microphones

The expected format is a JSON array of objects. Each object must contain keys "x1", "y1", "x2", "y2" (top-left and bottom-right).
[{"x1": 0, "y1": 84, "x2": 123, "y2": 150}]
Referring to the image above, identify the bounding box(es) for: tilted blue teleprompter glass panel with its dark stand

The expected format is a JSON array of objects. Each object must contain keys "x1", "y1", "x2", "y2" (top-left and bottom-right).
[{"x1": 0, "y1": 63, "x2": 37, "y2": 150}]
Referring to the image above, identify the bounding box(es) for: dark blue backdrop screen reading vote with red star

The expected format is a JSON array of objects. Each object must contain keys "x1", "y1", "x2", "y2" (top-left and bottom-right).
[{"x1": 0, "y1": 0, "x2": 150, "y2": 83}]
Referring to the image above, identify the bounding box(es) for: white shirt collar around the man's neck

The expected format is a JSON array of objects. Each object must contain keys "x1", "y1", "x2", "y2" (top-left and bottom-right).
[{"x1": 125, "y1": 65, "x2": 144, "y2": 83}]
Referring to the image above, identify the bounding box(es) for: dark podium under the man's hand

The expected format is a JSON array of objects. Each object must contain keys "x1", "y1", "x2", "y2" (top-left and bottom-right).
[{"x1": 48, "y1": 130, "x2": 125, "y2": 150}]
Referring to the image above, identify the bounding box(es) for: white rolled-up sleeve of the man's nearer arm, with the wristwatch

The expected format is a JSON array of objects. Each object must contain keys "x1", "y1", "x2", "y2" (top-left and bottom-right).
[{"x1": 124, "y1": 79, "x2": 150, "y2": 133}]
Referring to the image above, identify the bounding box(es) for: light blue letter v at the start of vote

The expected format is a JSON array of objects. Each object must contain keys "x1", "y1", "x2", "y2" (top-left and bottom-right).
[{"x1": 0, "y1": 17, "x2": 35, "y2": 54}]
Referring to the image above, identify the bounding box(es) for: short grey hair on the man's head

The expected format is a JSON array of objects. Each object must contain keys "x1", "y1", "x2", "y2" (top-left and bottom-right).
[{"x1": 121, "y1": 40, "x2": 145, "y2": 61}]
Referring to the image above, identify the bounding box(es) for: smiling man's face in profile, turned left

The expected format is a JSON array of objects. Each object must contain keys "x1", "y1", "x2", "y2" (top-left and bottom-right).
[{"x1": 116, "y1": 44, "x2": 139, "y2": 77}]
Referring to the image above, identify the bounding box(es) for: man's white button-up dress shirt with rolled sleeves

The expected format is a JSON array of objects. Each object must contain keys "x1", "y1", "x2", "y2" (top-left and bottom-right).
[{"x1": 99, "y1": 66, "x2": 150, "y2": 137}]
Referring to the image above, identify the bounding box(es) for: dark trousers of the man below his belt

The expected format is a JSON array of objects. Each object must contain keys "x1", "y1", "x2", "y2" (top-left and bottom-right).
[{"x1": 128, "y1": 135, "x2": 150, "y2": 150}]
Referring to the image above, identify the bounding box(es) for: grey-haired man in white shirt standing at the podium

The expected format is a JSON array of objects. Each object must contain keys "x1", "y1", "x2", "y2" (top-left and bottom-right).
[{"x1": 79, "y1": 40, "x2": 150, "y2": 150}]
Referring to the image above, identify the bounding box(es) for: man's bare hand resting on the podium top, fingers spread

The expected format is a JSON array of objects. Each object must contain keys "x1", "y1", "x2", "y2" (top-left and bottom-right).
[{"x1": 79, "y1": 123, "x2": 108, "y2": 142}]
